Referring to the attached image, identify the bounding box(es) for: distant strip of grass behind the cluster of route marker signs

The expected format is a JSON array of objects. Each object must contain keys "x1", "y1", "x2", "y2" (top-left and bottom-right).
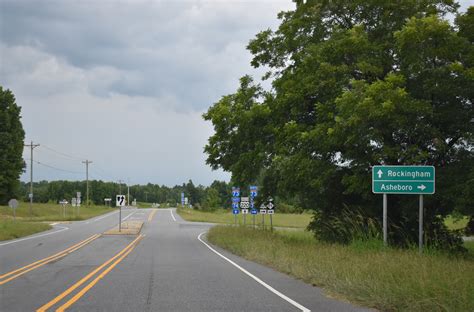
[{"x1": 177, "y1": 208, "x2": 312, "y2": 228}]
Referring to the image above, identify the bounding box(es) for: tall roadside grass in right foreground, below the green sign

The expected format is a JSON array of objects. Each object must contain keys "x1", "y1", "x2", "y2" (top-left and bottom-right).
[{"x1": 208, "y1": 226, "x2": 474, "y2": 311}]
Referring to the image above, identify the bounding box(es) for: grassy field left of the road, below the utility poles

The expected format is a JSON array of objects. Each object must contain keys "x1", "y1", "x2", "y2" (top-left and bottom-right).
[{"x1": 0, "y1": 203, "x2": 115, "y2": 241}]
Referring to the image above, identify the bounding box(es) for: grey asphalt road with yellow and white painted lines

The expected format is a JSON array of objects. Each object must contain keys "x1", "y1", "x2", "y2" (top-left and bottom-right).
[{"x1": 0, "y1": 209, "x2": 366, "y2": 312}]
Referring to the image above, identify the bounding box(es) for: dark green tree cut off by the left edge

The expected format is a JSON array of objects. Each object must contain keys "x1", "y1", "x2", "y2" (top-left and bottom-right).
[{"x1": 0, "y1": 86, "x2": 25, "y2": 204}]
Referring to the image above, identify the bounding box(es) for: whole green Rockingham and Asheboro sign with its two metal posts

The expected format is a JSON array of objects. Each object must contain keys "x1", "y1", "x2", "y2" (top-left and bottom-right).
[{"x1": 372, "y1": 166, "x2": 435, "y2": 253}]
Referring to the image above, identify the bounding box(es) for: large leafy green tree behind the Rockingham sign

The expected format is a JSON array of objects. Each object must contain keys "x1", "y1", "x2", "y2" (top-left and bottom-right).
[{"x1": 204, "y1": 0, "x2": 474, "y2": 247}]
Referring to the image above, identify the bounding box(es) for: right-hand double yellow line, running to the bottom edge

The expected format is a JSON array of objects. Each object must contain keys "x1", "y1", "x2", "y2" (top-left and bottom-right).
[{"x1": 36, "y1": 235, "x2": 144, "y2": 312}]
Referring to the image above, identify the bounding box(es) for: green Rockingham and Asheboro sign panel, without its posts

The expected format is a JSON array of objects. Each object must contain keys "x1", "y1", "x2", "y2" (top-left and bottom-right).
[{"x1": 372, "y1": 166, "x2": 435, "y2": 194}]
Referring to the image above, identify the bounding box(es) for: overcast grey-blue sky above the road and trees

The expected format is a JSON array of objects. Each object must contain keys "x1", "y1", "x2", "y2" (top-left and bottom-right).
[{"x1": 0, "y1": 0, "x2": 474, "y2": 186}]
